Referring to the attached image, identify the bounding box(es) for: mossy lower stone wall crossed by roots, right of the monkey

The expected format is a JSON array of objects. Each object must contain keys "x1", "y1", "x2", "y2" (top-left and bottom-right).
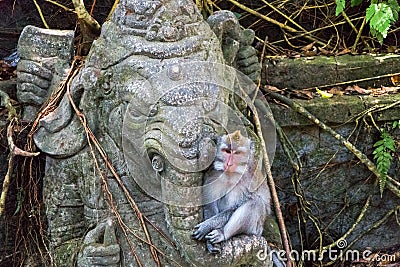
[{"x1": 270, "y1": 94, "x2": 400, "y2": 253}]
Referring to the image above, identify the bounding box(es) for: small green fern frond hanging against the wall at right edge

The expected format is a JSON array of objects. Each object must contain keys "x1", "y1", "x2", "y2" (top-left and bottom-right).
[{"x1": 372, "y1": 130, "x2": 398, "y2": 195}]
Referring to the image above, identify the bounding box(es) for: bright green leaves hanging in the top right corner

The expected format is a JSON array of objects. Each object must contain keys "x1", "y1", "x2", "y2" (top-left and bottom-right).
[{"x1": 336, "y1": 0, "x2": 400, "y2": 44}]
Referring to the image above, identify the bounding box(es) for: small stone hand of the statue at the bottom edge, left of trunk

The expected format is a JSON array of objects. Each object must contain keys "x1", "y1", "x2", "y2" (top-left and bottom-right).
[{"x1": 77, "y1": 218, "x2": 120, "y2": 267}]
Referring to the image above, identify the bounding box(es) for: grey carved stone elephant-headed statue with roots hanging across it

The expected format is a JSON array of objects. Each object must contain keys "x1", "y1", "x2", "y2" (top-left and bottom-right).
[{"x1": 18, "y1": 0, "x2": 278, "y2": 266}]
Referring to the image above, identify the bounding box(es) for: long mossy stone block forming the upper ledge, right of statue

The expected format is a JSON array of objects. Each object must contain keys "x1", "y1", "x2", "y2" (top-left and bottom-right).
[{"x1": 263, "y1": 54, "x2": 400, "y2": 89}]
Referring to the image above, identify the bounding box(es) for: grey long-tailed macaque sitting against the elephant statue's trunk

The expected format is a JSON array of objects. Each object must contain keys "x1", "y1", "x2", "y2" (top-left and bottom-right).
[{"x1": 193, "y1": 131, "x2": 271, "y2": 253}]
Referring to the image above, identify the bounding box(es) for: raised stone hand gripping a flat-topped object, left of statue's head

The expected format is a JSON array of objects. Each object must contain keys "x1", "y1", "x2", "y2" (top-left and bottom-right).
[{"x1": 17, "y1": 26, "x2": 74, "y2": 121}]
